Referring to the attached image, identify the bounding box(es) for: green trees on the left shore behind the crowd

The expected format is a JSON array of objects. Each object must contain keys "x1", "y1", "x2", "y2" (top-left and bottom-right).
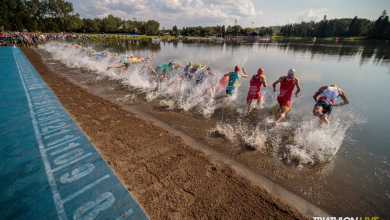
[{"x1": 0, "y1": 0, "x2": 160, "y2": 35}]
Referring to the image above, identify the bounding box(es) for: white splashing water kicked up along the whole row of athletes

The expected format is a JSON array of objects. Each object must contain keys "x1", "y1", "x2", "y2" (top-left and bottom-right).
[{"x1": 40, "y1": 44, "x2": 356, "y2": 168}]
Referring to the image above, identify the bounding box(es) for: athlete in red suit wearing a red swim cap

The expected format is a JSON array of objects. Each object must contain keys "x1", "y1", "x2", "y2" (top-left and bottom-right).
[{"x1": 246, "y1": 68, "x2": 267, "y2": 113}]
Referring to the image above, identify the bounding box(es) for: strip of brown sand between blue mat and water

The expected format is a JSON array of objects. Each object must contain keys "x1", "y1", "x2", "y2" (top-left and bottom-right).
[{"x1": 21, "y1": 48, "x2": 316, "y2": 219}]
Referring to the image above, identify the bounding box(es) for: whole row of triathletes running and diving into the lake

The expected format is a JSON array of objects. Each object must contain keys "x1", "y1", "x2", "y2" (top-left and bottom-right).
[{"x1": 55, "y1": 42, "x2": 349, "y2": 127}]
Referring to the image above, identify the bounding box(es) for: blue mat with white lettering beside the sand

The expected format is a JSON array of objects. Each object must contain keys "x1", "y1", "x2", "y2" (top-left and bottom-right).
[{"x1": 0, "y1": 47, "x2": 148, "y2": 220}]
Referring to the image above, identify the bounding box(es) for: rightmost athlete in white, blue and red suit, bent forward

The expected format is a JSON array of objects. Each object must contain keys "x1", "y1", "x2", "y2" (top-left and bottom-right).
[{"x1": 313, "y1": 85, "x2": 349, "y2": 127}]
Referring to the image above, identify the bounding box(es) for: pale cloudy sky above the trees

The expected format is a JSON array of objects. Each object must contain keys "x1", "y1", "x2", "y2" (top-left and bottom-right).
[{"x1": 71, "y1": 0, "x2": 390, "y2": 29}]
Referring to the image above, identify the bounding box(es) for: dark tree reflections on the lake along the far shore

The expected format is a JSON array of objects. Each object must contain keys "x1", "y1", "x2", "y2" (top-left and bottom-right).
[{"x1": 88, "y1": 40, "x2": 390, "y2": 65}]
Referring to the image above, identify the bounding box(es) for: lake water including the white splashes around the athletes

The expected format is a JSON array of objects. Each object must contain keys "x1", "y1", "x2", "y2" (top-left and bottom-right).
[{"x1": 40, "y1": 41, "x2": 390, "y2": 217}]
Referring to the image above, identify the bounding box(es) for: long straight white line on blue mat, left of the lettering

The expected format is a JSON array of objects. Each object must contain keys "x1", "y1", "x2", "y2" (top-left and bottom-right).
[{"x1": 13, "y1": 50, "x2": 67, "y2": 220}]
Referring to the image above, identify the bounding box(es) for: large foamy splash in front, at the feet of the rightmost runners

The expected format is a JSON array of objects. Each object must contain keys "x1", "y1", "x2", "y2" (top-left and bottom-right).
[{"x1": 210, "y1": 113, "x2": 351, "y2": 169}]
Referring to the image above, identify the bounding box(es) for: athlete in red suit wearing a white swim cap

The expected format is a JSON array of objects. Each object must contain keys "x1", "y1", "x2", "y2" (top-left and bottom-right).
[{"x1": 272, "y1": 69, "x2": 301, "y2": 127}]
